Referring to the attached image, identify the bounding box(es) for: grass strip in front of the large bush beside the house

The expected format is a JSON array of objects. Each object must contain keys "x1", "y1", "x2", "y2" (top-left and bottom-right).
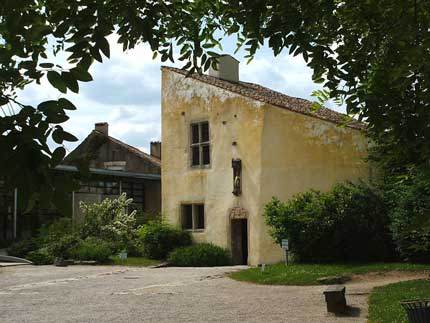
[{"x1": 230, "y1": 263, "x2": 430, "y2": 285}]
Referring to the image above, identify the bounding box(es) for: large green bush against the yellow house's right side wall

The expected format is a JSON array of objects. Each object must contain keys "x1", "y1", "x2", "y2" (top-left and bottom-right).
[{"x1": 264, "y1": 183, "x2": 395, "y2": 262}]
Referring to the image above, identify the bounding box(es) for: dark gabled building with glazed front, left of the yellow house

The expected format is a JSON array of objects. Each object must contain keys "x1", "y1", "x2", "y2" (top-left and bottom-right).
[{"x1": 0, "y1": 122, "x2": 161, "y2": 245}]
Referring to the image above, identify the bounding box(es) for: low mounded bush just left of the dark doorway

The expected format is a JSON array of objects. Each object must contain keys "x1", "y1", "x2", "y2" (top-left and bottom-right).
[{"x1": 167, "y1": 243, "x2": 232, "y2": 267}]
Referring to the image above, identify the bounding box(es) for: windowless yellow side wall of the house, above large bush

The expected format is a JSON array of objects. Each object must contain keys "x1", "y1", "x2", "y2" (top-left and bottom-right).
[{"x1": 260, "y1": 107, "x2": 369, "y2": 263}]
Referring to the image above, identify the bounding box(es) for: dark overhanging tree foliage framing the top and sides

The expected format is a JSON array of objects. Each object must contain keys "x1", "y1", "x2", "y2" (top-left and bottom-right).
[{"x1": 0, "y1": 0, "x2": 430, "y2": 208}]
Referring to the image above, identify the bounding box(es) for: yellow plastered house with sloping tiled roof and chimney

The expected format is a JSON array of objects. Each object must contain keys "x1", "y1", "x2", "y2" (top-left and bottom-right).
[{"x1": 162, "y1": 55, "x2": 370, "y2": 265}]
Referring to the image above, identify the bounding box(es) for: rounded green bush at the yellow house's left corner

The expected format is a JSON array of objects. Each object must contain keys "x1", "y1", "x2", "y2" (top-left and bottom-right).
[{"x1": 138, "y1": 221, "x2": 191, "y2": 259}]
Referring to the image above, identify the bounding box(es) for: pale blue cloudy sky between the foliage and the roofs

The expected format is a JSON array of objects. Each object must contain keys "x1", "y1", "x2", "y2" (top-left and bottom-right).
[{"x1": 15, "y1": 36, "x2": 344, "y2": 152}]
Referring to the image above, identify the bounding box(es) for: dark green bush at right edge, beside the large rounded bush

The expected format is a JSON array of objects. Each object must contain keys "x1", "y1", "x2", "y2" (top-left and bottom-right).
[{"x1": 387, "y1": 171, "x2": 430, "y2": 262}]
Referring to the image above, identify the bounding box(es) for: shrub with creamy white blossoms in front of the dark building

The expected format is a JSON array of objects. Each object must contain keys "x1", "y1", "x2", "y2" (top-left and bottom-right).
[{"x1": 80, "y1": 194, "x2": 136, "y2": 251}]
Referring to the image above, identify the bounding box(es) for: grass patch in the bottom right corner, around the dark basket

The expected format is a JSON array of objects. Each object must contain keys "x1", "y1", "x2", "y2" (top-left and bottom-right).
[{"x1": 369, "y1": 280, "x2": 430, "y2": 323}]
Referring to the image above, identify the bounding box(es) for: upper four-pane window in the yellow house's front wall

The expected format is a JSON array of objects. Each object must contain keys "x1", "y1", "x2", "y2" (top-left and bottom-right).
[{"x1": 191, "y1": 121, "x2": 211, "y2": 166}]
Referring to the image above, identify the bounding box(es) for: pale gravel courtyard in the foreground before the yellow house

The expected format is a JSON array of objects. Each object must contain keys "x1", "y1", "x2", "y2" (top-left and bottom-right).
[{"x1": 0, "y1": 266, "x2": 428, "y2": 323}]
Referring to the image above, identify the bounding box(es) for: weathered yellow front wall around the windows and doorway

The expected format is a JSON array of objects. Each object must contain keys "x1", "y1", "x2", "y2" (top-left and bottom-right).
[{"x1": 161, "y1": 70, "x2": 264, "y2": 264}]
